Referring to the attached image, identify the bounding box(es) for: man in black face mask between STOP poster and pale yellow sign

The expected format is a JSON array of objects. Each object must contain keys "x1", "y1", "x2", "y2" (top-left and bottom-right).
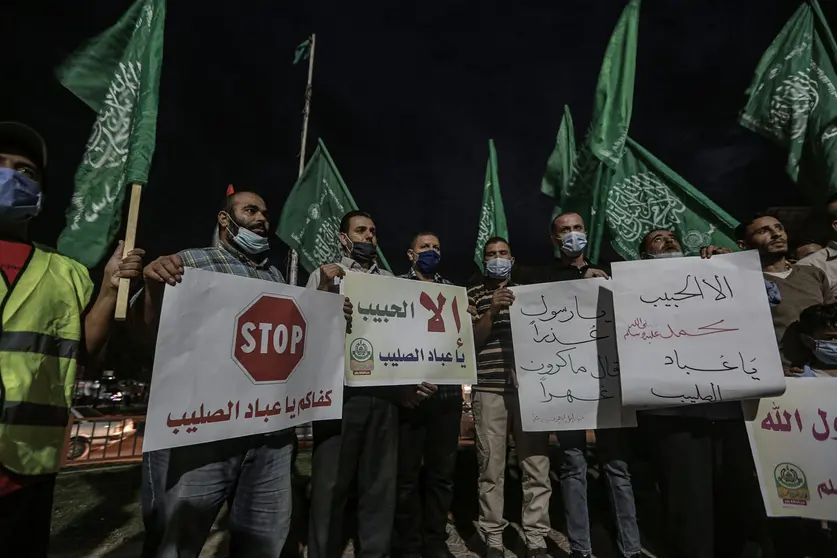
[{"x1": 306, "y1": 211, "x2": 404, "y2": 558}]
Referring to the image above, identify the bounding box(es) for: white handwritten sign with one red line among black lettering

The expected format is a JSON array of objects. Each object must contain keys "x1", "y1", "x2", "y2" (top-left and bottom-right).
[{"x1": 613, "y1": 251, "x2": 785, "y2": 408}]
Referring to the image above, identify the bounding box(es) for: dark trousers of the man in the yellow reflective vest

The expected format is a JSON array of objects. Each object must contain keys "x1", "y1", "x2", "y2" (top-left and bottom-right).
[{"x1": 0, "y1": 475, "x2": 56, "y2": 558}]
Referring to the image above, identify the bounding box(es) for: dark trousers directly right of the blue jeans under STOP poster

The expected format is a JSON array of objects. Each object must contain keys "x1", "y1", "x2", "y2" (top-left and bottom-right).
[{"x1": 308, "y1": 390, "x2": 398, "y2": 558}]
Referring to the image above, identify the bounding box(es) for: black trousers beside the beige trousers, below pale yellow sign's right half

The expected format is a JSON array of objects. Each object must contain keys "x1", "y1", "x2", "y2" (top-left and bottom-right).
[{"x1": 392, "y1": 398, "x2": 462, "y2": 558}]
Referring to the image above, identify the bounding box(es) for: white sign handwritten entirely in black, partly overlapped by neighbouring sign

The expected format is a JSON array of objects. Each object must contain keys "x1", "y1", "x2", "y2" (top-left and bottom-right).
[{"x1": 510, "y1": 279, "x2": 636, "y2": 432}]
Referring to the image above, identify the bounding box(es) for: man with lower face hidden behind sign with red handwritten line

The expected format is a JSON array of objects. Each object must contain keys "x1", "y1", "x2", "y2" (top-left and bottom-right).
[{"x1": 637, "y1": 229, "x2": 756, "y2": 558}]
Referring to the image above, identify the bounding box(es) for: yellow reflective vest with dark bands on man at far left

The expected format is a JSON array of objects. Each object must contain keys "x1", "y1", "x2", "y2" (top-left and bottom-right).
[{"x1": 0, "y1": 246, "x2": 93, "y2": 475}]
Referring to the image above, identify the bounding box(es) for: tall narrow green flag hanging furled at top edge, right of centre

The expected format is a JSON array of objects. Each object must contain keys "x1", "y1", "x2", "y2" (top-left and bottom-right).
[{"x1": 587, "y1": 0, "x2": 640, "y2": 167}]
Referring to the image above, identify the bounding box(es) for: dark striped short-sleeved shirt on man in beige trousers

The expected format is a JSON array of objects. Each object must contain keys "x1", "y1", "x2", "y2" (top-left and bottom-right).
[{"x1": 468, "y1": 283, "x2": 514, "y2": 391}]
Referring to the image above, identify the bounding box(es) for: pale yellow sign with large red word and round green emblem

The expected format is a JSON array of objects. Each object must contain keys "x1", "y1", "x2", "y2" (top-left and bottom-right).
[{"x1": 343, "y1": 272, "x2": 477, "y2": 386}]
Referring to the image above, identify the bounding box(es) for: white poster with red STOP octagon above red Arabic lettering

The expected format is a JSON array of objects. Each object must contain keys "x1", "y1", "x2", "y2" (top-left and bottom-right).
[{"x1": 143, "y1": 268, "x2": 346, "y2": 458}]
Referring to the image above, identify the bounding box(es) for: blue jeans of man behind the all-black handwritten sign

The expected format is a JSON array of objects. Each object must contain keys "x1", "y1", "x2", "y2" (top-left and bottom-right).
[{"x1": 556, "y1": 428, "x2": 642, "y2": 556}]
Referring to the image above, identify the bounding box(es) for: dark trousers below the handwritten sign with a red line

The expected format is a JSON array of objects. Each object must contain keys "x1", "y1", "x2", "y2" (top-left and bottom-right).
[{"x1": 639, "y1": 413, "x2": 764, "y2": 558}]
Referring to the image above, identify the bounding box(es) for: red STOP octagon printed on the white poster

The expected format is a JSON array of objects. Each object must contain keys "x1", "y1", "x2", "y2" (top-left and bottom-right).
[{"x1": 233, "y1": 294, "x2": 308, "y2": 383}]
